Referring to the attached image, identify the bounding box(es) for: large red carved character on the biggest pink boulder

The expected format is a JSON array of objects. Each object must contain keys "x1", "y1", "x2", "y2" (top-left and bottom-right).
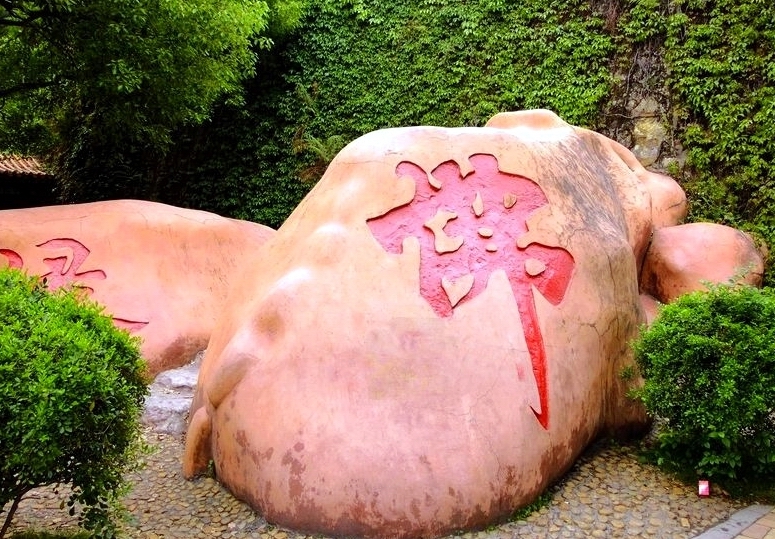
[{"x1": 368, "y1": 154, "x2": 574, "y2": 428}]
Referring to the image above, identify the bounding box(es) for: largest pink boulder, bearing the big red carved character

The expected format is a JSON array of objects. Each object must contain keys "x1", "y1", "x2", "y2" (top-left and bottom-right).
[{"x1": 184, "y1": 111, "x2": 760, "y2": 537}]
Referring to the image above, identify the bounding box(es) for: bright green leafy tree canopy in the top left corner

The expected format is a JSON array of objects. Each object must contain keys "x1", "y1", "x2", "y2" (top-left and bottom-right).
[{"x1": 0, "y1": 0, "x2": 301, "y2": 153}]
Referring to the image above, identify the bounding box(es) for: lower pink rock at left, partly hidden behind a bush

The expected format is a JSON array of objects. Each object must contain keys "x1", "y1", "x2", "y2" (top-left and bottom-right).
[{"x1": 0, "y1": 200, "x2": 274, "y2": 375}]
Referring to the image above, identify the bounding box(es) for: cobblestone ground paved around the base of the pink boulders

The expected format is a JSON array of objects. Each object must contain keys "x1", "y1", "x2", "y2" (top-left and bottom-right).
[{"x1": 6, "y1": 432, "x2": 743, "y2": 539}]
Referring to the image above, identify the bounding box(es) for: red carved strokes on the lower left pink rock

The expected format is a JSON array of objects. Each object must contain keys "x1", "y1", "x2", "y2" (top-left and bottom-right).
[{"x1": 0, "y1": 238, "x2": 148, "y2": 332}]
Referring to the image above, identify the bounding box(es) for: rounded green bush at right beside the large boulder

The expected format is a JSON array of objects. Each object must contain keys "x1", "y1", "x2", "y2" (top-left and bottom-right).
[{"x1": 634, "y1": 286, "x2": 775, "y2": 480}]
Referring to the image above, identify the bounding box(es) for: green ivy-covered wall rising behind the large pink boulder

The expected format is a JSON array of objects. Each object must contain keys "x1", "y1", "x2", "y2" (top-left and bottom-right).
[{"x1": 126, "y1": 0, "x2": 775, "y2": 284}]
